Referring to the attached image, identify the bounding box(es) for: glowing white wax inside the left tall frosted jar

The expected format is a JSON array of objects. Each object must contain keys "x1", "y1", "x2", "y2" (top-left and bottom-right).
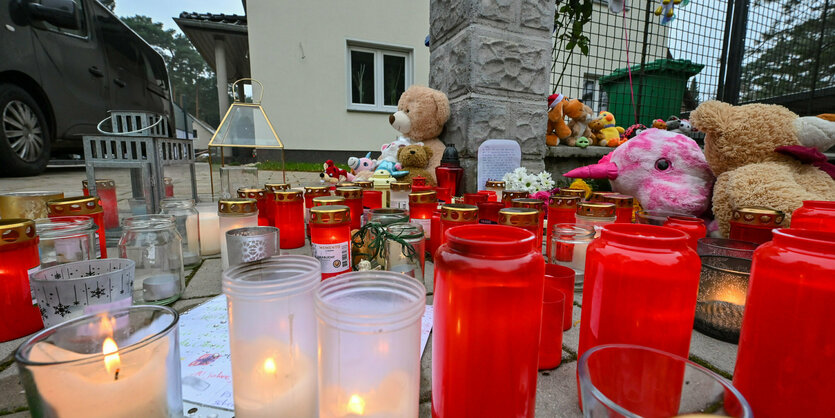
[{"x1": 230, "y1": 337, "x2": 318, "y2": 418}]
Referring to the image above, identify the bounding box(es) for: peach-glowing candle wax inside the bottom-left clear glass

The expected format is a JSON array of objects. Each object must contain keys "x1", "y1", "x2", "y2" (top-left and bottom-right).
[{"x1": 29, "y1": 339, "x2": 171, "y2": 418}]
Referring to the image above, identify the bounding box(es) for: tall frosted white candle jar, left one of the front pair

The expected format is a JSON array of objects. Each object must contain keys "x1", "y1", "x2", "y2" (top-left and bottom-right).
[{"x1": 223, "y1": 255, "x2": 321, "y2": 418}]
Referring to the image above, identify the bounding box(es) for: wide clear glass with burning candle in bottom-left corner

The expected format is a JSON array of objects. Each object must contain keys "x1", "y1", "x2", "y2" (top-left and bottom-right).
[{"x1": 15, "y1": 305, "x2": 183, "y2": 418}]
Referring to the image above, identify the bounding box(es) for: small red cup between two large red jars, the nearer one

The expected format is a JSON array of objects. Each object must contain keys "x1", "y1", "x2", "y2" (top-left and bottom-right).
[{"x1": 539, "y1": 286, "x2": 567, "y2": 370}]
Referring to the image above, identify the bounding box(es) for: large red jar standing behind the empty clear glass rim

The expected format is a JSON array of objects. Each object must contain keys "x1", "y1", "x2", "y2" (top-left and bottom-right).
[{"x1": 577, "y1": 224, "x2": 701, "y2": 410}]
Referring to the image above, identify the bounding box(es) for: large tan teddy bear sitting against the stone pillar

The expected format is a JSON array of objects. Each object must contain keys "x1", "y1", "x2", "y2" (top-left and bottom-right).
[{"x1": 389, "y1": 86, "x2": 449, "y2": 182}]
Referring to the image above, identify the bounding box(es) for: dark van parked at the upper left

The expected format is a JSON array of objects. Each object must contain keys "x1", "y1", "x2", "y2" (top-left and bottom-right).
[{"x1": 0, "y1": 0, "x2": 171, "y2": 176}]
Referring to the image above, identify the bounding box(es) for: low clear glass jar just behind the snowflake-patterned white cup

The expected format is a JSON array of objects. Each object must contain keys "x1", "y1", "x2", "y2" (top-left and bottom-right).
[{"x1": 35, "y1": 216, "x2": 98, "y2": 268}]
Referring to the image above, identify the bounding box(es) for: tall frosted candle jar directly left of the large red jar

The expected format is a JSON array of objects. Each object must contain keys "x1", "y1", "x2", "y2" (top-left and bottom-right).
[{"x1": 315, "y1": 271, "x2": 426, "y2": 418}]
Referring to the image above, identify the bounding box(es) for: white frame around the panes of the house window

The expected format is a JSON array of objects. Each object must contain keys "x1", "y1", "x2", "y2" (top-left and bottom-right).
[{"x1": 345, "y1": 39, "x2": 414, "y2": 113}]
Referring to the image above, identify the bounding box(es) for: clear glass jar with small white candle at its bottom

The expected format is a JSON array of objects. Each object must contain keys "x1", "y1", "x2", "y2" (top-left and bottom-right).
[{"x1": 119, "y1": 215, "x2": 185, "y2": 305}]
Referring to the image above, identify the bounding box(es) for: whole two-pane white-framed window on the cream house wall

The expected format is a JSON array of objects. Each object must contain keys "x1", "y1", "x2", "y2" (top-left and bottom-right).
[{"x1": 347, "y1": 41, "x2": 412, "y2": 113}]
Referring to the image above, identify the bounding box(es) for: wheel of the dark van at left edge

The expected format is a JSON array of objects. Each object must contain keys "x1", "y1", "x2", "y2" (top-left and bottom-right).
[{"x1": 0, "y1": 84, "x2": 52, "y2": 176}]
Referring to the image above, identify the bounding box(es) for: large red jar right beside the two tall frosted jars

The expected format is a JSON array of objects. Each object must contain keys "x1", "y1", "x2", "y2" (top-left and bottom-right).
[{"x1": 432, "y1": 225, "x2": 545, "y2": 417}]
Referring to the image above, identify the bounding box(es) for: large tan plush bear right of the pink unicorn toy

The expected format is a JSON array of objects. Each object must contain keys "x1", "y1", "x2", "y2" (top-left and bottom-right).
[{"x1": 690, "y1": 101, "x2": 835, "y2": 237}]
